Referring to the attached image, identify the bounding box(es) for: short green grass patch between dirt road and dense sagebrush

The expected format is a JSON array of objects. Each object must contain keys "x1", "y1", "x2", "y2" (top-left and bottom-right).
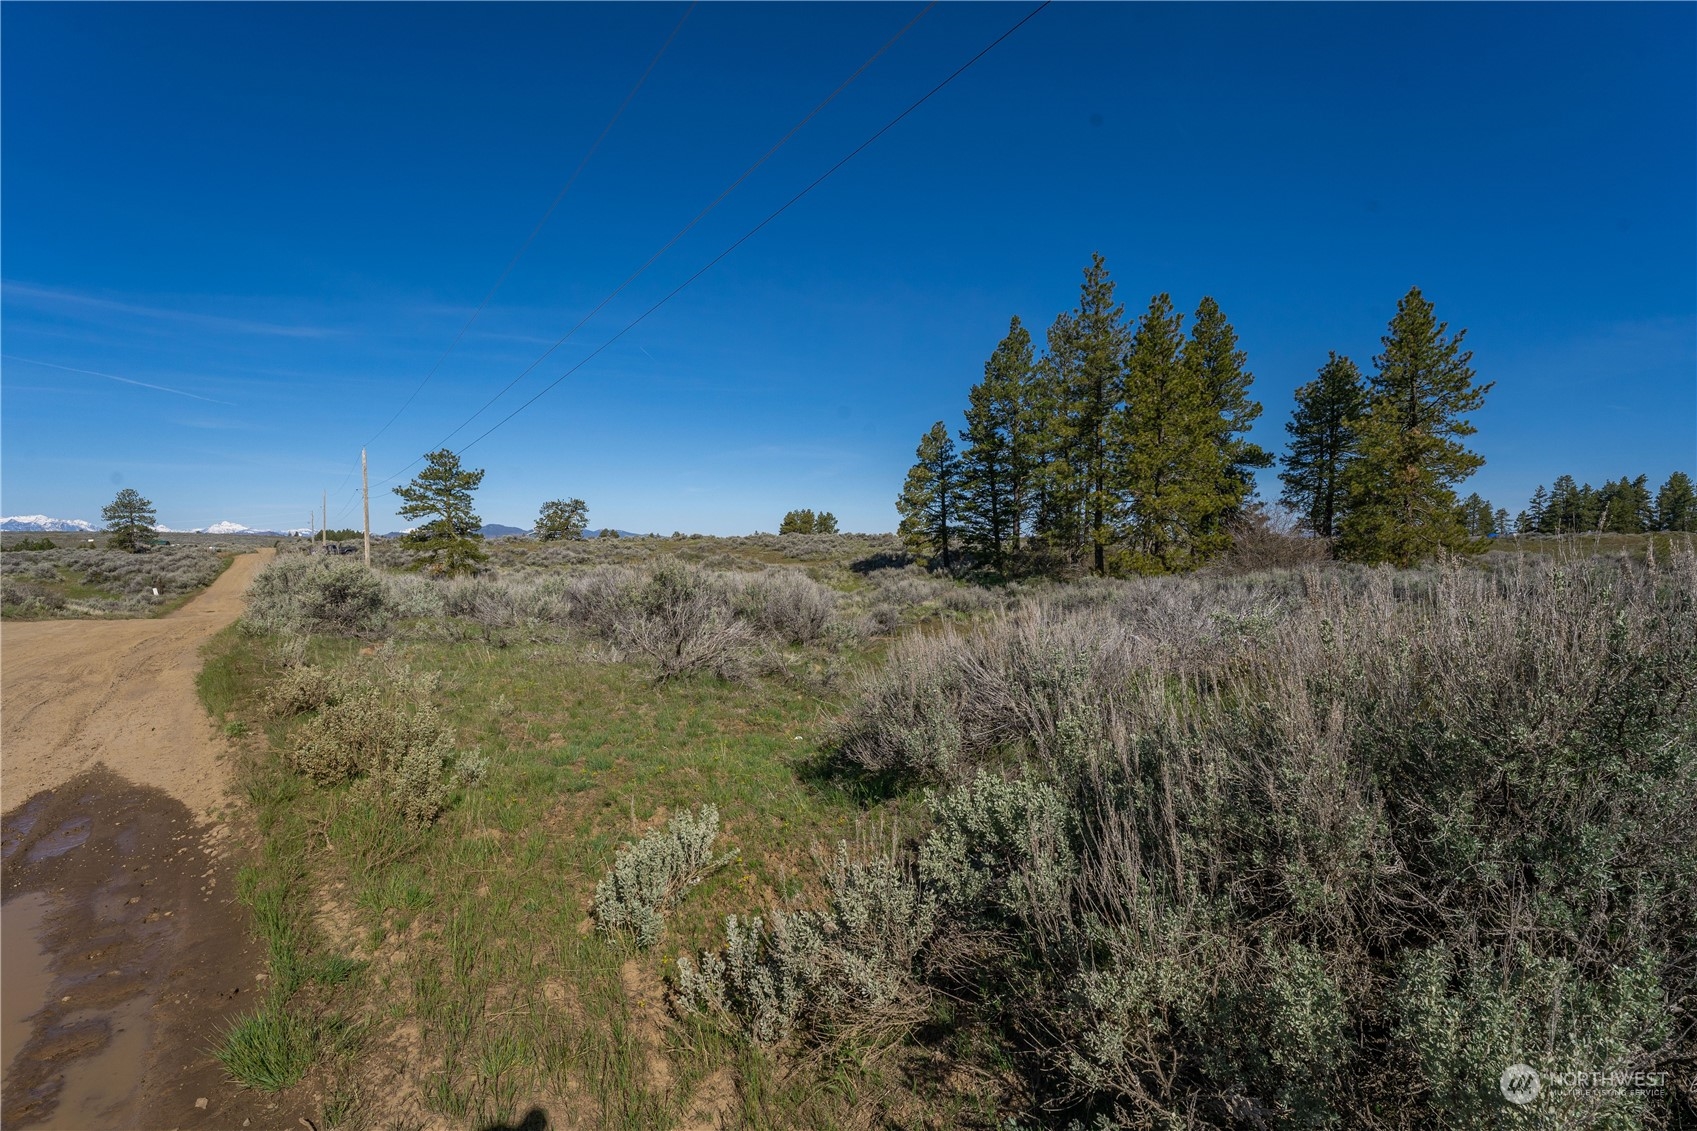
[{"x1": 199, "y1": 607, "x2": 916, "y2": 1128}]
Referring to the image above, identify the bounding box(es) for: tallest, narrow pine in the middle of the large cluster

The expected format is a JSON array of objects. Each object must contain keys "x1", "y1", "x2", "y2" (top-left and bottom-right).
[{"x1": 1045, "y1": 253, "x2": 1125, "y2": 574}]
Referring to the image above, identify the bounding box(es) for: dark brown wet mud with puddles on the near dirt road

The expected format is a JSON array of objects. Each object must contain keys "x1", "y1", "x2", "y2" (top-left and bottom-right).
[{"x1": 0, "y1": 768, "x2": 300, "y2": 1131}]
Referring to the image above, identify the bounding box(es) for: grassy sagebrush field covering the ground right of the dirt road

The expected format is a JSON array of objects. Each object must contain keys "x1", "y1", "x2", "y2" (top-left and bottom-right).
[{"x1": 202, "y1": 521, "x2": 1697, "y2": 1129}]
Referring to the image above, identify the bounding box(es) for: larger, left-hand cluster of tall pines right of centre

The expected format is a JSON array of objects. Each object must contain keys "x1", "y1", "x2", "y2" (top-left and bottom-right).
[{"x1": 896, "y1": 255, "x2": 1271, "y2": 574}]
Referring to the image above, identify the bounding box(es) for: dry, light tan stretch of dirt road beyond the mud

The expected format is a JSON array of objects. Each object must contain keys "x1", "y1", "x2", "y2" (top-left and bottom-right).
[{"x1": 0, "y1": 550, "x2": 275, "y2": 817}]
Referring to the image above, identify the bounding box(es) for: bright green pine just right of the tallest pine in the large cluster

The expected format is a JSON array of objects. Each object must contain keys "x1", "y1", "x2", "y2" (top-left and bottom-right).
[{"x1": 1113, "y1": 294, "x2": 1241, "y2": 572}]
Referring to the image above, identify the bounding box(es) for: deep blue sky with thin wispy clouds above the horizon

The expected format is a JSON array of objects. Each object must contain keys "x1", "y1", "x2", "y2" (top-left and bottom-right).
[{"x1": 0, "y1": 3, "x2": 1697, "y2": 533}]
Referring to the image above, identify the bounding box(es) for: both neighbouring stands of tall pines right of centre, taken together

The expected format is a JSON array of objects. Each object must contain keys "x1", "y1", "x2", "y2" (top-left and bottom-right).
[{"x1": 896, "y1": 255, "x2": 1507, "y2": 574}]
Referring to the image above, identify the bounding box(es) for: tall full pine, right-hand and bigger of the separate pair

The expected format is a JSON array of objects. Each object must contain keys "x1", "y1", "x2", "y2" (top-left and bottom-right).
[{"x1": 1339, "y1": 287, "x2": 1492, "y2": 566}]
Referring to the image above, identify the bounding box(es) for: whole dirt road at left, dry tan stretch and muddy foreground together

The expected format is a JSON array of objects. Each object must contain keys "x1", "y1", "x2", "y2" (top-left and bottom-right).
[{"x1": 0, "y1": 550, "x2": 302, "y2": 1131}]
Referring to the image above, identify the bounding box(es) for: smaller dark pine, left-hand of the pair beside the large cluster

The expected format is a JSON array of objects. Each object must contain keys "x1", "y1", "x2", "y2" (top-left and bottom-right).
[{"x1": 1280, "y1": 352, "x2": 1366, "y2": 538}]
